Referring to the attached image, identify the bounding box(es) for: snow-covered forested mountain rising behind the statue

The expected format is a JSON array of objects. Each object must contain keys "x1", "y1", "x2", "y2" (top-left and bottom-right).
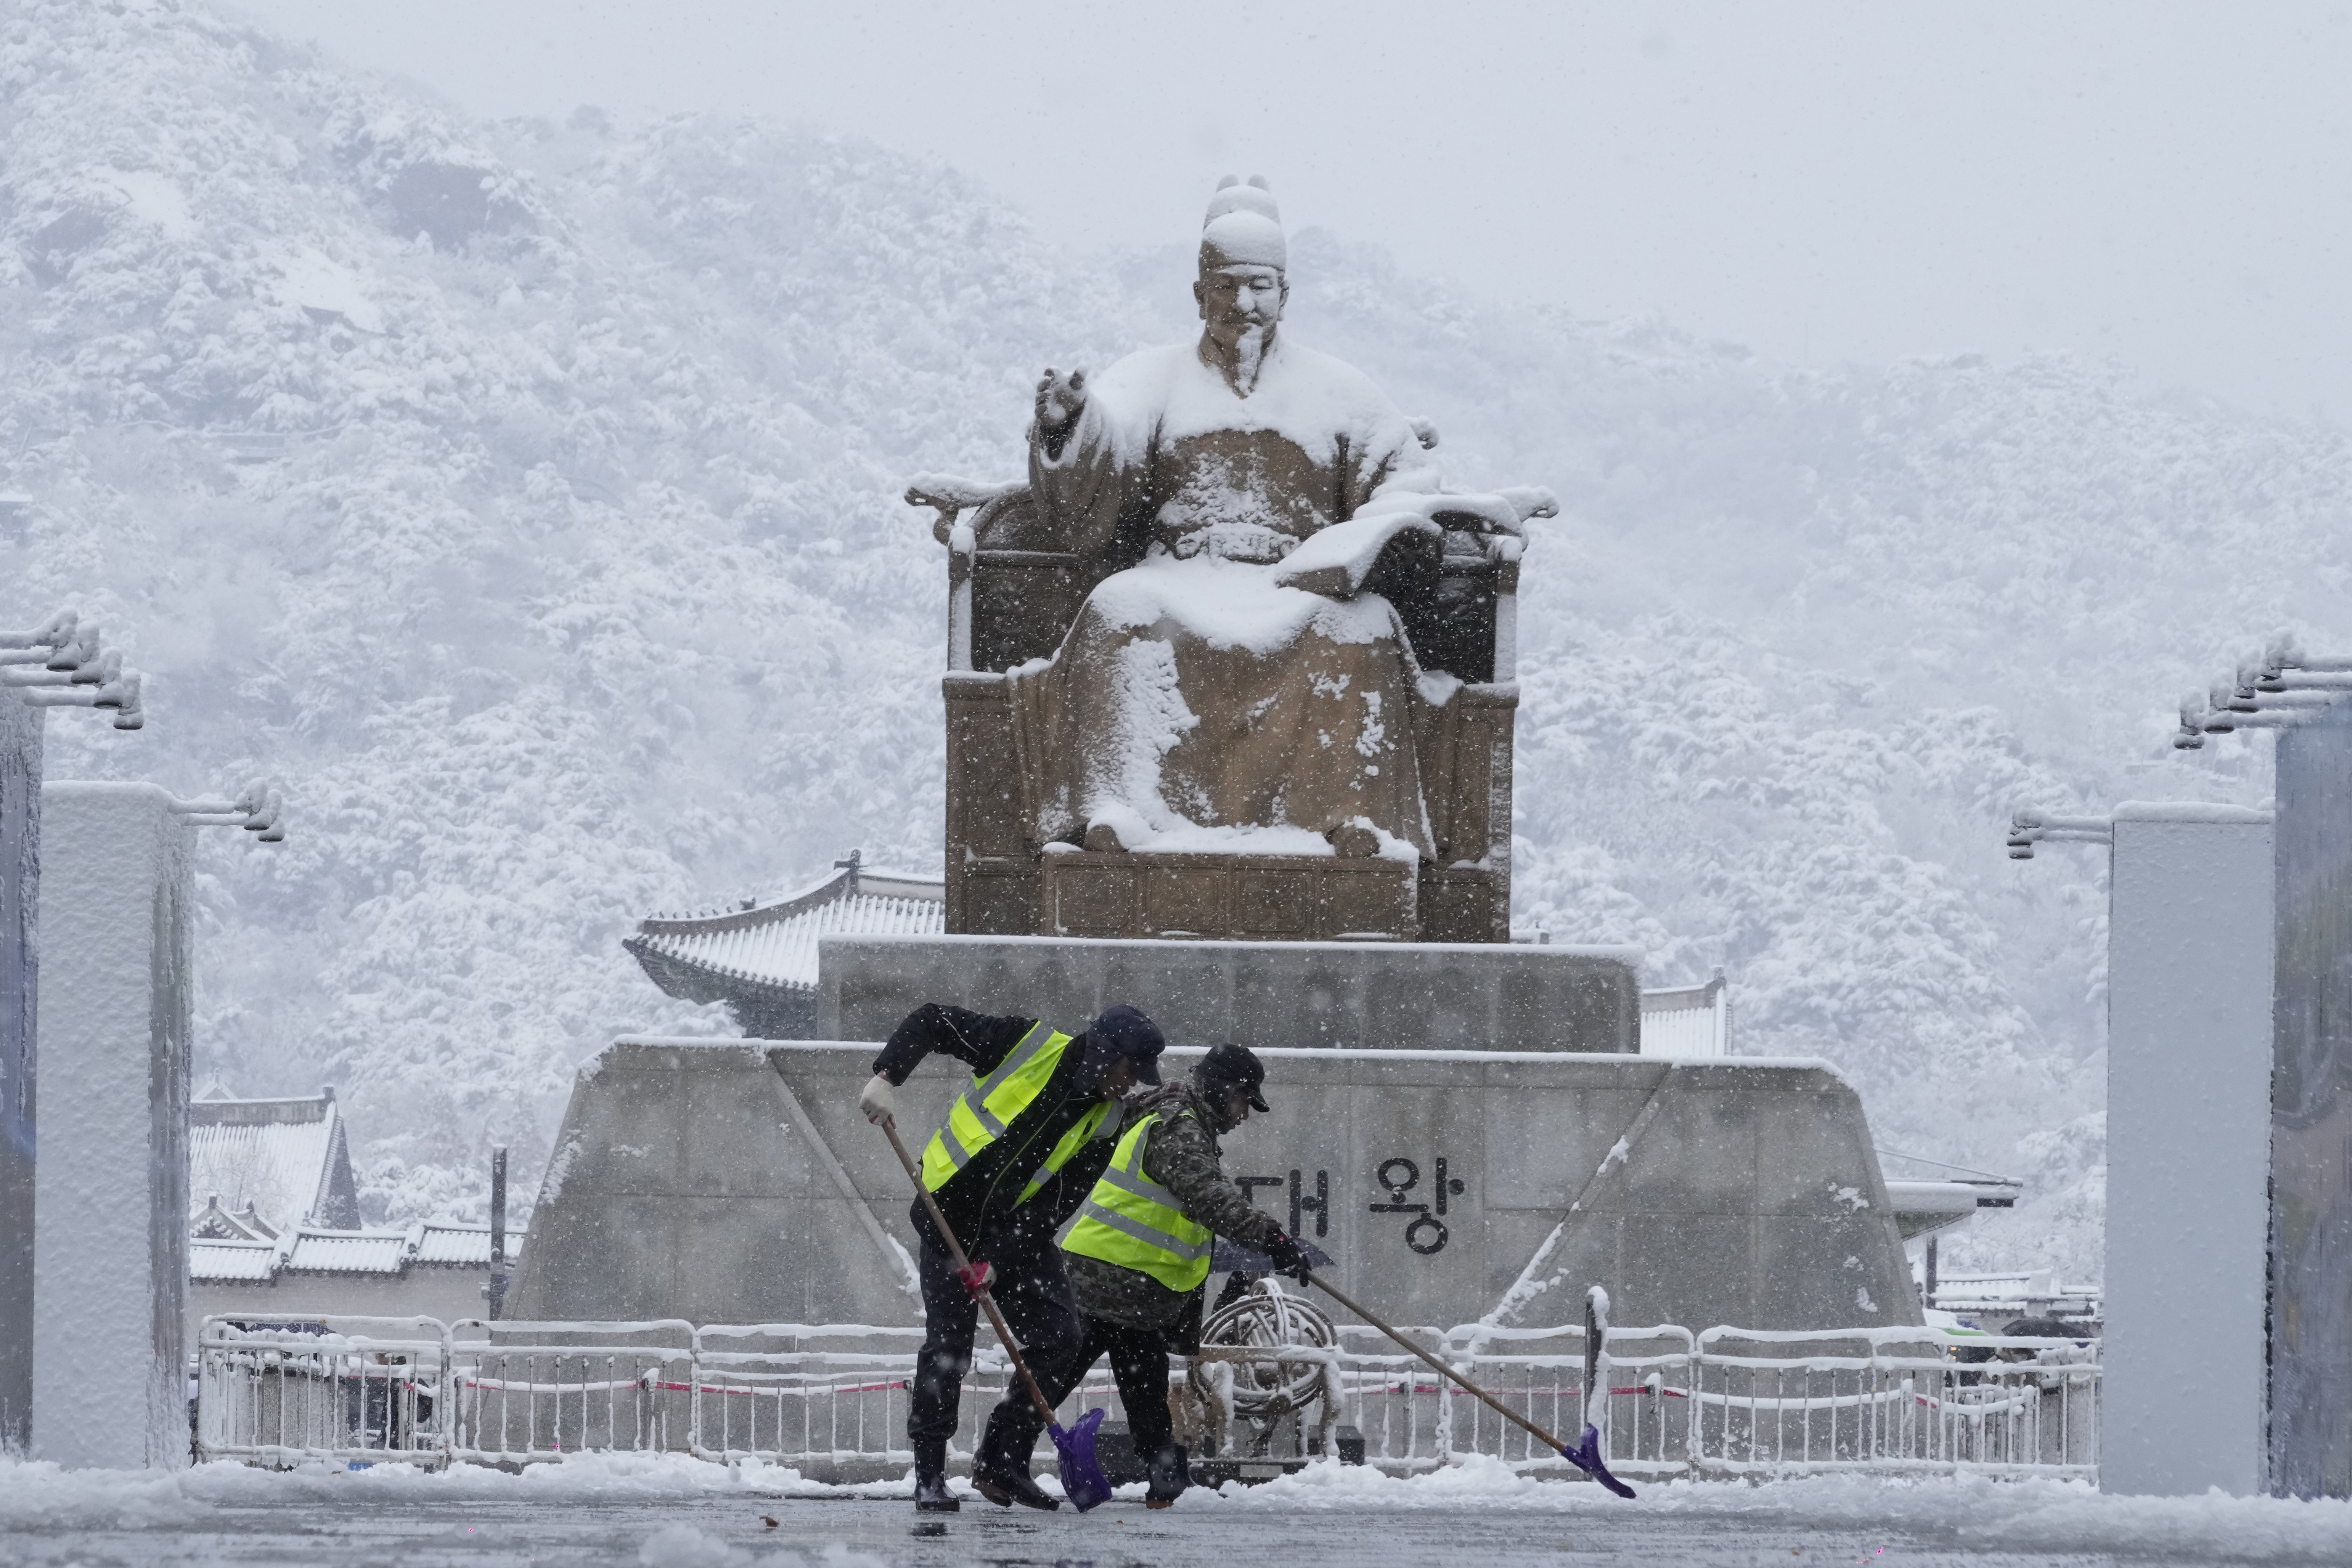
[{"x1": 0, "y1": 0, "x2": 2352, "y2": 1274}]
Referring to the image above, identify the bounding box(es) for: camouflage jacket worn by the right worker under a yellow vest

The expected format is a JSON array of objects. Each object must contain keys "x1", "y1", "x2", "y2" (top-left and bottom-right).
[{"x1": 1063, "y1": 1084, "x2": 1282, "y2": 1352}]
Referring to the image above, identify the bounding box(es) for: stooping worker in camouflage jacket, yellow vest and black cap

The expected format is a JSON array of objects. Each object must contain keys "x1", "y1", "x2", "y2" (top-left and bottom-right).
[{"x1": 976, "y1": 1046, "x2": 1310, "y2": 1509}]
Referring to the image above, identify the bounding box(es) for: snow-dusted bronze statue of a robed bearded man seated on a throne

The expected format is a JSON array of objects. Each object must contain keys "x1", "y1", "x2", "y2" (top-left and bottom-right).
[{"x1": 908, "y1": 179, "x2": 1552, "y2": 940}]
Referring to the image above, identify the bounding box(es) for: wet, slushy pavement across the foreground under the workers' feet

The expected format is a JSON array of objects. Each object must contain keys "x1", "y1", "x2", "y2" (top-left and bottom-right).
[{"x1": 0, "y1": 1486, "x2": 2352, "y2": 1568}]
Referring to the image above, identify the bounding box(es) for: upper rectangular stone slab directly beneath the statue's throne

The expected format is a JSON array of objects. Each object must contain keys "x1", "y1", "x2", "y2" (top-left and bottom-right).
[{"x1": 816, "y1": 931, "x2": 1642, "y2": 1053}]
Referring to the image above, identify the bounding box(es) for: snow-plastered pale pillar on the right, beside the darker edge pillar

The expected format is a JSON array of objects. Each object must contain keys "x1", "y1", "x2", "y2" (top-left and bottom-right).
[{"x1": 2100, "y1": 804, "x2": 2272, "y2": 1497}]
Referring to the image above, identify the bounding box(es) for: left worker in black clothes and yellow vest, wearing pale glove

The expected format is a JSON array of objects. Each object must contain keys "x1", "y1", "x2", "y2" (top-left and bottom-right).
[{"x1": 858, "y1": 1001, "x2": 1166, "y2": 1514}]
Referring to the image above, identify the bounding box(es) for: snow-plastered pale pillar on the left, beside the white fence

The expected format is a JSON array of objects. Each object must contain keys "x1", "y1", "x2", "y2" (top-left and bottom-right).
[{"x1": 33, "y1": 783, "x2": 193, "y2": 1469}]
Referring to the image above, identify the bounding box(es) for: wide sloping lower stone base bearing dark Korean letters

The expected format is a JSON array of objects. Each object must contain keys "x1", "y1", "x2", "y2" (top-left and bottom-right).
[{"x1": 508, "y1": 1039, "x2": 1919, "y2": 1350}]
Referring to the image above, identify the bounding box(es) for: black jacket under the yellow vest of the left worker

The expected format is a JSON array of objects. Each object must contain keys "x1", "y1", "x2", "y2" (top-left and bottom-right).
[{"x1": 875, "y1": 1001, "x2": 1120, "y2": 1253}]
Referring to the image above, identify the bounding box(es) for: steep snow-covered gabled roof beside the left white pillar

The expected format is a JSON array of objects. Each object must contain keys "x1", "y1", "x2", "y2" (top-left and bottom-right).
[{"x1": 188, "y1": 1088, "x2": 360, "y2": 1232}]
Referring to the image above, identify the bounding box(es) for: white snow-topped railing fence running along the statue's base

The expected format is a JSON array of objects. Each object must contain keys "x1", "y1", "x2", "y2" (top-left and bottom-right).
[{"x1": 195, "y1": 1319, "x2": 2100, "y2": 1481}]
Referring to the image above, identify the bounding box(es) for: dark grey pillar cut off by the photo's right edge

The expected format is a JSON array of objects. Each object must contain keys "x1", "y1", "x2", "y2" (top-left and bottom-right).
[{"x1": 2270, "y1": 705, "x2": 2352, "y2": 1497}]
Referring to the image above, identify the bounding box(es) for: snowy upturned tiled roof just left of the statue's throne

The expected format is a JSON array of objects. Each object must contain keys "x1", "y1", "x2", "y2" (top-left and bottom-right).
[{"x1": 621, "y1": 865, "x2": 948, "y2": 1001}]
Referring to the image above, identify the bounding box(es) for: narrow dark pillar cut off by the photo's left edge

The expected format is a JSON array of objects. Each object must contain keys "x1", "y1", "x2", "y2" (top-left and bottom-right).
[{"x1": 0, "y1": 689, "x2": 40, "y2": 1453}]
